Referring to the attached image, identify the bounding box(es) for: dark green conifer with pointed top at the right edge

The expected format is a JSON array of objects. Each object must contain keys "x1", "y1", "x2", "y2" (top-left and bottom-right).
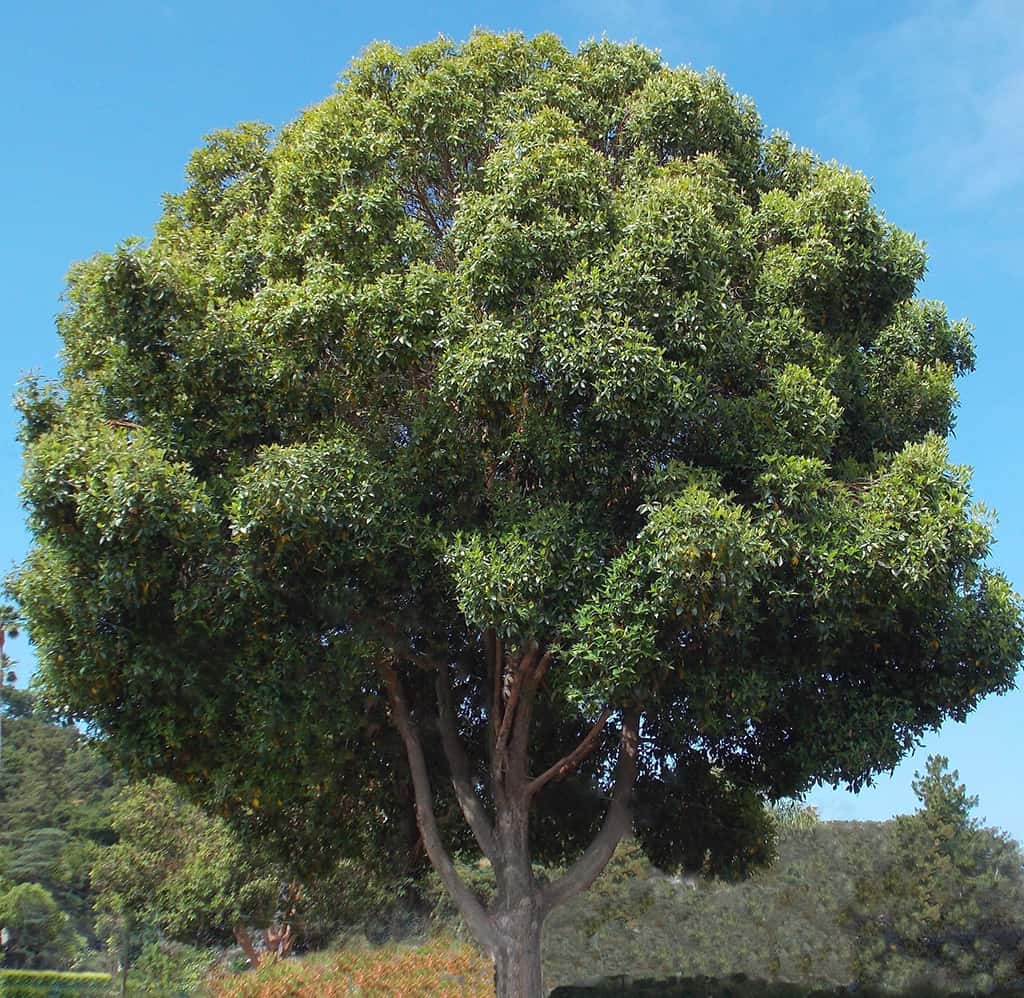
[{"x1": 857, "y1": 755, "x2": 1024, "y2": 991}]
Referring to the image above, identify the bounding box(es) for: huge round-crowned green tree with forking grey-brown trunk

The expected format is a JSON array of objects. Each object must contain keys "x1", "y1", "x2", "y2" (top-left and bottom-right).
[{"x1": 9, "y1": 34, "x2": 1024, "y2": 998}]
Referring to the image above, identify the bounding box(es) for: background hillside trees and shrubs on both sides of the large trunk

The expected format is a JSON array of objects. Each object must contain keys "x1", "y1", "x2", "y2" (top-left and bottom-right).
[{"x1": 0, "y1": 689, "x2": 1024, "y2": 998}]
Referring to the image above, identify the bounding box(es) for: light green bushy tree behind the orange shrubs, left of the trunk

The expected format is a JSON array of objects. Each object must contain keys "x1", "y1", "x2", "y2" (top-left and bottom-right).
[{"x1": 91, "y1": 779, "x2": 411, "y2": 966}]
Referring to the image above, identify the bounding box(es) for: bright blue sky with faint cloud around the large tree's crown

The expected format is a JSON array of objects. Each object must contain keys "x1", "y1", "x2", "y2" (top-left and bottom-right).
[{"x1": 0, "y1": 0, "x2": 1024, "y2": 840}]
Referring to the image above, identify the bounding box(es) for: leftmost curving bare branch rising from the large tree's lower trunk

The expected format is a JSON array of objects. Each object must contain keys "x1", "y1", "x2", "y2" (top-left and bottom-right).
[{"x1": 378, "y1": 660, "x2": 498, "y2": 954}]
